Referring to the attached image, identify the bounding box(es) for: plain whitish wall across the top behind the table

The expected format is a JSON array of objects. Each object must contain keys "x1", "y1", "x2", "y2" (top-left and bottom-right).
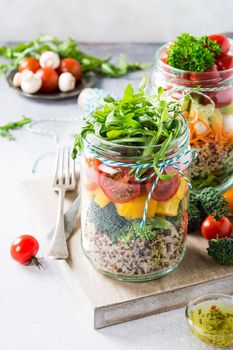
[{"x1": 0, "y1": 0, "x2": 233, "y2": 42}]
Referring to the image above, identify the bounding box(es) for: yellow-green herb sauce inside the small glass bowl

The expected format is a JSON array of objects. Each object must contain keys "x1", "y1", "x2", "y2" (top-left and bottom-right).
[{"x1": 189, "y1": 302, "x2": 233, "y2": 346}]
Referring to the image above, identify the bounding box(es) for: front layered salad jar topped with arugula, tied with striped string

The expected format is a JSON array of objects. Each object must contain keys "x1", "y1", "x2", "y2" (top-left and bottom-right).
[{"x1": 74, "y1": 79, "x2": 192, "y2": 281}]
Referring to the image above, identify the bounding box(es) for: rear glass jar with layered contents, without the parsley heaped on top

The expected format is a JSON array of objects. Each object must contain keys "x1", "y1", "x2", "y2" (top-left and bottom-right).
[{"x1": 151, "y1": 45, "x2": 233, "y2": 189}]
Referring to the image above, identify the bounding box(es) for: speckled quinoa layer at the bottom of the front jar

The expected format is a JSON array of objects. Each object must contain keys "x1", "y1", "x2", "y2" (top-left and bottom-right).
[{"x1": 82, "y1": 221, "x2": 185, "y2": 275}]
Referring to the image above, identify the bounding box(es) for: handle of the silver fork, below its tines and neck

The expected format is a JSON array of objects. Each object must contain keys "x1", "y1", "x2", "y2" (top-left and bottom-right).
[{"x1": 48, "y1": 188, "x2": 68, "y2": 259}]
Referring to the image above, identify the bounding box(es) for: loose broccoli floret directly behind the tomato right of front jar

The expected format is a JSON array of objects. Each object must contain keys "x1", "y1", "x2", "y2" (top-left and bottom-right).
[{"x1": 197, "y1": 187, "x2": 229, "y2": 219}]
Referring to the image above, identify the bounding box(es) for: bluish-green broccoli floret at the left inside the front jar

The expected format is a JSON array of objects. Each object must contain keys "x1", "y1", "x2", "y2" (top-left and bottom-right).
[{"x1": 87, "y1": 201, "x2": 128, "y2": 242}]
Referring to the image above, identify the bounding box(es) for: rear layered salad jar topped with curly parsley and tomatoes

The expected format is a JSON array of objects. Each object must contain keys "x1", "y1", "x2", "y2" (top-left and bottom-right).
[{"x1": 152, "y1": 33, "x2": 233, "y2": 189}]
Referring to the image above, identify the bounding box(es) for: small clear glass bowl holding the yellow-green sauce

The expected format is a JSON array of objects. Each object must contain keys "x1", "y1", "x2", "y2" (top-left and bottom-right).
[{"x1": 185, "y1": 294, "x2": 233, "y2": 349}]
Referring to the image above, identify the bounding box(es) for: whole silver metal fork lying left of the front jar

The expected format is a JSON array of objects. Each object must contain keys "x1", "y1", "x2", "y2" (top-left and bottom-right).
[{"x1": 48, "y1": 148, "x2": 76, "y2": 259}]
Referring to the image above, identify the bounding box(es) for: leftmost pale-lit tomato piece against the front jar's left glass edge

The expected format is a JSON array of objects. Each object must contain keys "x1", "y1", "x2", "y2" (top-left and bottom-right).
[{"x1": 84, "y1": 157, "x2": 101, "y2": 191}]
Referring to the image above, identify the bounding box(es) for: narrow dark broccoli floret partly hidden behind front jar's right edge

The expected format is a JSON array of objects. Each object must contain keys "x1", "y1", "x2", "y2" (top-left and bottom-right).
[{"x1": 188, "y1": 192, "x2": 202, "y2": 232}]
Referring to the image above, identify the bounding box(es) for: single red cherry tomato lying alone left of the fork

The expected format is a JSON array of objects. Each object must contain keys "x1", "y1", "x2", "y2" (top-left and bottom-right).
[{"x1": 10, "y1": 235, "x2": 39, "y2": 265}]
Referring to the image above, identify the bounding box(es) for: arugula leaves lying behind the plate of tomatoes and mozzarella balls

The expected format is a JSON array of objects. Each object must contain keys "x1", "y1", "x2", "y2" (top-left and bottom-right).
[{"x1": 0, "y1": 36, "x2": 149, "y2": 77}]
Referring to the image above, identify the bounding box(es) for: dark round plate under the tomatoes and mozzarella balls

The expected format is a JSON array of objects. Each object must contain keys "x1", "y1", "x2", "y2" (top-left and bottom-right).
[{"x1": 6, "y1": 69, "x2": 97, "y2": 100}]
